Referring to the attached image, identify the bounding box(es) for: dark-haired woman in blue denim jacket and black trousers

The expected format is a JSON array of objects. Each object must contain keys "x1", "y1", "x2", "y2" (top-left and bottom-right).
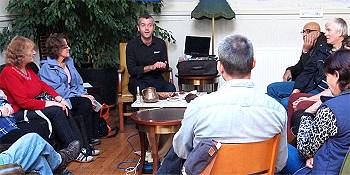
[{"x1": 39, "y1": 33, "x2": 101, "y2": 161}]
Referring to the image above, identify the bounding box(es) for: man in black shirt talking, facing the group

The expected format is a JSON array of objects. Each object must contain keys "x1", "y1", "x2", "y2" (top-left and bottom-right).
[{"x1": 126, "y1": 15, "x2": 176, "y2": 95}]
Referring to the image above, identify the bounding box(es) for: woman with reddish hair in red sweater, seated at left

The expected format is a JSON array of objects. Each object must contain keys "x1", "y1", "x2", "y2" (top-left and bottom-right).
[{"x1": 0, "y1": 36, "x2": 79, "y2": 150}]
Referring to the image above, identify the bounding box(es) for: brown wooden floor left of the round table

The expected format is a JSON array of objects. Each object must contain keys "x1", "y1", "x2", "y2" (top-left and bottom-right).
[{"x1": 68, "y1": 110, "x2": 140, "y2": 175}]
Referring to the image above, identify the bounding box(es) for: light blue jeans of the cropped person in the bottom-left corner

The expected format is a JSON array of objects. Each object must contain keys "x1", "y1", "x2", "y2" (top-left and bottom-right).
[{"x1": 0, "y1": 133, "x2": 62, "y2": 175}]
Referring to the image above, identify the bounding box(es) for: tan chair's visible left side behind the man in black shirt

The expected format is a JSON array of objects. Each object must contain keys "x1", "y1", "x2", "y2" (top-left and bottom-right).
[{"x1": 119, "y1": 43, "x2": 131, "y2": 94}]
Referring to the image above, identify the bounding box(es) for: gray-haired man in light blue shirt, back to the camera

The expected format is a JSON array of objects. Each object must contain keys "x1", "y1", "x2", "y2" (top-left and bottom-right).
[{"x1": 158, "y1": 35, "x2": 287, "y2": 174}]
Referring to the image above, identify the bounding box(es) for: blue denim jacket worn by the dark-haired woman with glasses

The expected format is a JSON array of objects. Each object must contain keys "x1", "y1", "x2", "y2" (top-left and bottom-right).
[{"x1": 39, "y1": 57, "x2": 86, "y2": 109}]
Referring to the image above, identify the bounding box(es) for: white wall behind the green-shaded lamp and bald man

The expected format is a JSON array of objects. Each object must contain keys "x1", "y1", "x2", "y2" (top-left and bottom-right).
[{"x1": 155, "y1": 0, "x2": 350, "y2": 91}]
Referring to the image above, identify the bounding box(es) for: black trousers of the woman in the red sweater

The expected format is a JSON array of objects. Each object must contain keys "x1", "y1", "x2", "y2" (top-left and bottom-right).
[{"x1": 14, "y1": 106, "x2": 79, "y2": 147}]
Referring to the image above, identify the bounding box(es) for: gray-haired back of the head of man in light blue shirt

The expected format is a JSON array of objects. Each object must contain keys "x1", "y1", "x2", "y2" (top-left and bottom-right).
[{"x1": 218, "y1": 35, "x2": 254, "y2": 76}]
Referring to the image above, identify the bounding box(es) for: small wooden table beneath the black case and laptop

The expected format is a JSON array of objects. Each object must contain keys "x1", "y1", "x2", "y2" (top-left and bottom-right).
[{"x1": 175, "y1": 74, "x2": 220, "y2": 91}]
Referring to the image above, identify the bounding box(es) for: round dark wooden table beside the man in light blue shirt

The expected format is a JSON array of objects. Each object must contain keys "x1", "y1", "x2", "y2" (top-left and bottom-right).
[{"x1": 131, "y1": 108, "x2": 186, "y2": 174}]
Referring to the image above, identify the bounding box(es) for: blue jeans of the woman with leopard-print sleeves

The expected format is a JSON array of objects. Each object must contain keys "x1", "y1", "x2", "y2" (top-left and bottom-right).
[{"x1": 279, "y1": 144, "x2": 306, "y2": 174}]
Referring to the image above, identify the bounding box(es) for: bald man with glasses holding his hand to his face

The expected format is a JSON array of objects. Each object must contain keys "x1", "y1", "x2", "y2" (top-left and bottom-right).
[{"x1": 267, "y1": 22, "x2": 332, "y2": 109}]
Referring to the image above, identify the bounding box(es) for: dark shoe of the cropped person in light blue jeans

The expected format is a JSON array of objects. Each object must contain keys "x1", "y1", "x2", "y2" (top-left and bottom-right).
[{"x1": 58, "y1": 140, "x2": 80, "y2": 170}]
